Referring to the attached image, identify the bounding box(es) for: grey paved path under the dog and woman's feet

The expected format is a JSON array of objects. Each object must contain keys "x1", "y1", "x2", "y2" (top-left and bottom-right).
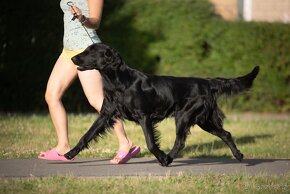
[{"x1": 0, "y1": 158, "x2": 290, "y2": 178}]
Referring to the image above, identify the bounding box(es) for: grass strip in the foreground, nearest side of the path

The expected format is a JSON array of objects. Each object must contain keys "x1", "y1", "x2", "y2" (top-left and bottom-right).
[{"x1": 0, "y1": 174, "x2": 290, "y2": 194}]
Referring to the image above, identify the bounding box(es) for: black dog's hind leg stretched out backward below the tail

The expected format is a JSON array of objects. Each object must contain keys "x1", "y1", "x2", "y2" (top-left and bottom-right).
[{"x1": 198, "y1": 114, "x2": 244, "y2": 161}]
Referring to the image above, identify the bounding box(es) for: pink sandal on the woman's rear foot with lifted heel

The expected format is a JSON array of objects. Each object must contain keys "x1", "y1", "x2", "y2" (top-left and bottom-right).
[{"x1": 110, "y1": 146, "x2": 141, "y2": 164}]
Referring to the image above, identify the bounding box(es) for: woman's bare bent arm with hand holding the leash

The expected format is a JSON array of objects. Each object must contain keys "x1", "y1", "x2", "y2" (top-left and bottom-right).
[{"x1": 71, "y1": 0, "x2": 104, "y2": 29}]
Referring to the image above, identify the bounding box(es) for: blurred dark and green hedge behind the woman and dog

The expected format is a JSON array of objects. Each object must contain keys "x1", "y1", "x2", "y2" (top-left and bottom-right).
[{"x1": 0, "y1": 0, "x2": 290, "y2": 112}]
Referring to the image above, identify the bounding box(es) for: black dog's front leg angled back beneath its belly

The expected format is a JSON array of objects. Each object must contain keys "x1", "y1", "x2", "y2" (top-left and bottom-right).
[{"x1": 139, "y1": 118, "x2": 172, "y2": 166}]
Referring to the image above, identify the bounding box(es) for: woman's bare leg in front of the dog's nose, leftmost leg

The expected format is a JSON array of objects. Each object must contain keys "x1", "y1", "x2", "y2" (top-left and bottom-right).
[{"x1": 45, "y1": 55, "x2": 77, "y2": 155}]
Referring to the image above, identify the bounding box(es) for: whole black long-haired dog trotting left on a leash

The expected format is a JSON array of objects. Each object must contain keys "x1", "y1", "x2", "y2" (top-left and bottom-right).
[{"x1": 65, "y1": 44, "x2": 259, "y2": 166}]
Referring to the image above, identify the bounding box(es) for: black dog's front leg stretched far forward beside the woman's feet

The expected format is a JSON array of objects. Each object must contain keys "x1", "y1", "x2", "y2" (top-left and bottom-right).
[{"x1": 64, "y1": 114, "x2": 115, "y2": 160}]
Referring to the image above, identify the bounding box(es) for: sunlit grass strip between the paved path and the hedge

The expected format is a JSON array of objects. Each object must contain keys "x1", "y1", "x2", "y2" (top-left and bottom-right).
[{"x1": 0, "y1": 114, "x2": 290, "y2": 158}]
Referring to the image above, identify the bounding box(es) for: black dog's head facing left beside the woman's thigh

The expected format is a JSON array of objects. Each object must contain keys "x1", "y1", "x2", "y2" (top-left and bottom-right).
[{"x1": 72, "y1": 43, "x2": 122, "y2": 71}]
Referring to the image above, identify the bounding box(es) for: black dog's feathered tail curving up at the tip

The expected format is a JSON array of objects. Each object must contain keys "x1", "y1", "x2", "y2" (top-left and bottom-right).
[{"x1": 211, "y1": 66, "x2": 260, "y2": 97}]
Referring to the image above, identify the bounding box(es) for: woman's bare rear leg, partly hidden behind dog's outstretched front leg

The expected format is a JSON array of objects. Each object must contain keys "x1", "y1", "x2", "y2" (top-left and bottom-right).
[{"x1": 78, "y1": 70, "x2": 132, "y2": 152}]
